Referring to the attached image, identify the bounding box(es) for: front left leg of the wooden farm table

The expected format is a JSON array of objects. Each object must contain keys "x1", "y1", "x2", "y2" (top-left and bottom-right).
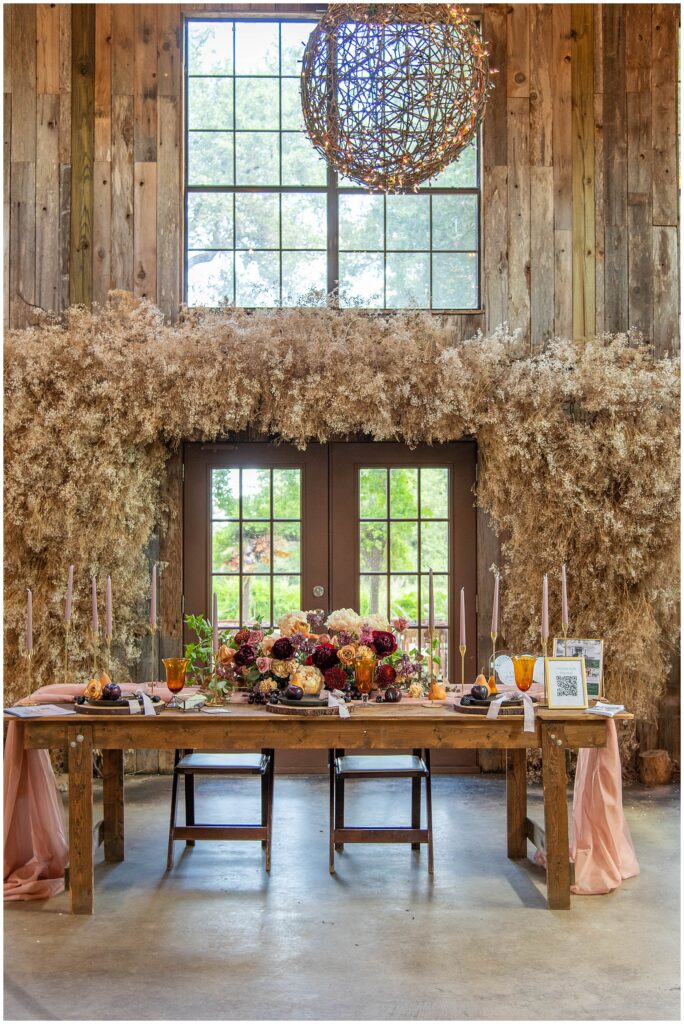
[{"x1": 68, "y1": 725, "x2": 93, "y2": 913}]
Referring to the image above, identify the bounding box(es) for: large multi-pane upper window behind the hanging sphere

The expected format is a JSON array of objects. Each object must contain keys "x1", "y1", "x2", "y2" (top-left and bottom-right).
[{"x1": 185, "y1": 18, "x2": 480, "y2": 309}]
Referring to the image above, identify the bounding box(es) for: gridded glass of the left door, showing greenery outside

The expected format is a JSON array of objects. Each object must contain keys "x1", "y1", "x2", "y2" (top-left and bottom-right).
[{"x1": 209, "y1": 467, "x2": 302, "y2": 627}]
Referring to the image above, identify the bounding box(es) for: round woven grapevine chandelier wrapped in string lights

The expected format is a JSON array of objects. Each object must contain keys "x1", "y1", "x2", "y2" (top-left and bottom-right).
[{"x1": 301, "y1": 3, "x2": 491, "y2": 193}]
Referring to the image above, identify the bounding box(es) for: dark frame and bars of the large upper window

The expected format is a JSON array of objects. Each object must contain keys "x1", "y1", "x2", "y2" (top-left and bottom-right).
[{"x1": 181, "y1": 8, "x2": 484, "y2": 316}]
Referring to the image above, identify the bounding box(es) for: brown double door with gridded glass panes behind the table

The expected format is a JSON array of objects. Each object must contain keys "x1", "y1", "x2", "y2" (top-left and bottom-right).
[{"x1": 183, "y1": 441, "x2": 476, "y2": 770}]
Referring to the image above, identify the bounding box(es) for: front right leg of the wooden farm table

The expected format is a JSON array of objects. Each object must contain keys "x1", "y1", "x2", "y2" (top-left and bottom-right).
[{"x1": 542, "y1": 723, "x2": 570, "y2": 910}]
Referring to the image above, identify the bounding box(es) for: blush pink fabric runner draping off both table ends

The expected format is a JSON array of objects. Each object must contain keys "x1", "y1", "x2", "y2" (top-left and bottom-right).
[{"x1": 4, "y1": 684, "x2": 639, "y2": 900}]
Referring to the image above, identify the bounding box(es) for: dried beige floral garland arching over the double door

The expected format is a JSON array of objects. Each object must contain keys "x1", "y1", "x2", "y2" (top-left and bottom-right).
[{"x1": 5, "y1": 293, "x2": 679, "y2": 761}]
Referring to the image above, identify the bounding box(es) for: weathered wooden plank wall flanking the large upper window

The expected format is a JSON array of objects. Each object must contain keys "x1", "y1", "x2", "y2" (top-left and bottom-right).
[{"x1": 3, "y1": 3, "x2": 679, "y2": 352}]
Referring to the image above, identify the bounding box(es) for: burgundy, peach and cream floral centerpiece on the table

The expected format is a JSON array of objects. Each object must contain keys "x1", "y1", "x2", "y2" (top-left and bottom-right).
[{"x1": 185, "y1": 608, "x2": 424, "y2": 703}]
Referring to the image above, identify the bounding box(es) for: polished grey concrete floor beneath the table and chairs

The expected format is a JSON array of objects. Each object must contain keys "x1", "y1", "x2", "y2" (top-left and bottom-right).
[{"x1": 4, "y1": 776, "x2": 680, "y2": 1020}]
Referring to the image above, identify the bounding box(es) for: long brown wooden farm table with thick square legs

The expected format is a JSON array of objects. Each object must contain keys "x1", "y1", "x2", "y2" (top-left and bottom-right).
[{"x1": 10, "y1": 701, "x2": 632, "y2": 913}]
